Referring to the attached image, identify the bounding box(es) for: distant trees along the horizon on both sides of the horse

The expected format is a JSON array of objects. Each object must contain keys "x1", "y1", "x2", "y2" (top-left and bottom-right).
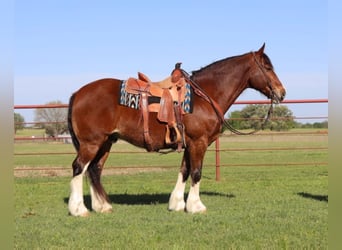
[{"x1": 14, "y1": 101, "x2": 328, "y2": 137}]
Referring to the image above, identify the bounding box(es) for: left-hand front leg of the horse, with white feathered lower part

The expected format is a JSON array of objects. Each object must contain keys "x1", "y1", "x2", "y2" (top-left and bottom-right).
[{"x1": 169, "y1": 149, "x2": 190, "y2": 211}]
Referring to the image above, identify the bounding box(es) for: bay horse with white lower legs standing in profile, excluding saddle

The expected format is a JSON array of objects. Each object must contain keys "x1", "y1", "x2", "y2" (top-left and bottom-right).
[{"x1": 68, "y1": 44, "x2": 286, "y2": 216}]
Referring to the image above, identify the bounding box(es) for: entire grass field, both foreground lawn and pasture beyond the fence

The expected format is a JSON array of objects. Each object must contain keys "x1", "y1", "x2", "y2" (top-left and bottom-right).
[{"x1": 14, "y1": 132, "x2": 328, "y2": 249}]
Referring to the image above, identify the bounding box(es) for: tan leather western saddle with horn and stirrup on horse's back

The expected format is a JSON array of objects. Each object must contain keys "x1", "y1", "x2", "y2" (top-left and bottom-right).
[{"x1": 125, "y1": 63, "x2": 186, "y2": 152}]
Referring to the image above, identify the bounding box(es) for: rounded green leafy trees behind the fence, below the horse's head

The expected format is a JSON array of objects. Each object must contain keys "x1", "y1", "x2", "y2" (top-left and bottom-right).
[{"x1": 229, "y1": 104, "x2": 295, "y2": 131}]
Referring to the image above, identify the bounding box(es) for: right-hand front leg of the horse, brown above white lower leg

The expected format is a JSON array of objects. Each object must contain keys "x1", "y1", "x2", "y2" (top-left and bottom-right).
[{"x1": 186, "y1": 142, "x2": 207, "y2": 213}]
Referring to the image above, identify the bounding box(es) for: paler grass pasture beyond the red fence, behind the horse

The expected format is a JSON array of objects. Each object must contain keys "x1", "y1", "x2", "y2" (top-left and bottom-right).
[{"x1": 14, "y1": 130, "x2": 328, "y2": 169}]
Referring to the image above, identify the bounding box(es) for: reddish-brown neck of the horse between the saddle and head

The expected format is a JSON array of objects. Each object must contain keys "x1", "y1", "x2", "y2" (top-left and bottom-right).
[{"x1": 194, "y1": 58, "x2": 250, "y2": 113}]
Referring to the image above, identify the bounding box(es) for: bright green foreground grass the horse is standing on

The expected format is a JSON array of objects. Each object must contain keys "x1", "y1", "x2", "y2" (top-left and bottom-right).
[{"x1": 14, "y1": 166, "x2": 328, "y2": 249}]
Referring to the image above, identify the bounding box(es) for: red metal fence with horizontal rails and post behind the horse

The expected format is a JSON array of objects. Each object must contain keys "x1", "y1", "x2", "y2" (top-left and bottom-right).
[{"x1": 14, "y1": 99, "x2": 328, "y2": 180}]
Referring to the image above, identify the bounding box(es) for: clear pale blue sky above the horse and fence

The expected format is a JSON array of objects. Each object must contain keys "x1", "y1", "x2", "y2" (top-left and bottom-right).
[{"x1": 14, "y1": 0, "x2": 328, "y2": 121}]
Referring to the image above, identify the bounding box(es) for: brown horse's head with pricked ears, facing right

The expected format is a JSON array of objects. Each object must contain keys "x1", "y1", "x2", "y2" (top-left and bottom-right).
[{"x1": 248, "y1": 44, "x2": 286, "y2": 103}]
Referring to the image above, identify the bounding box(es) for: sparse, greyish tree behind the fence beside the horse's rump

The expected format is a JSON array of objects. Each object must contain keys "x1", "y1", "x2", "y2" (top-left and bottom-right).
[{"x1": 35, "y1": 101, "x2": 68, "y2": 137}]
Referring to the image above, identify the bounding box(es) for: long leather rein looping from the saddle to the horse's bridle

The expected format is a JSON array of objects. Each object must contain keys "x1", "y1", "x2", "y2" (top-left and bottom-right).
[{"x1": 180, "y1": 52, "x2": 276, "y2": 135}]
